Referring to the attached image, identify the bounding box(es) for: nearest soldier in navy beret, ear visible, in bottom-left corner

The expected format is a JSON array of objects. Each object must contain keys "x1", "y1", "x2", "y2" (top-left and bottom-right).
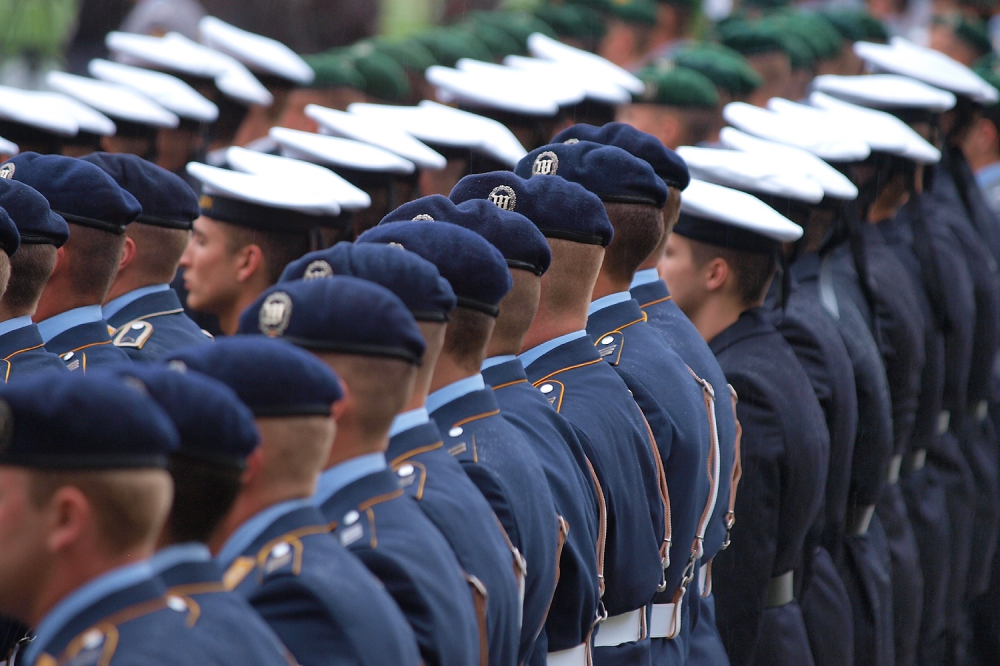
[{"x1": 0, "y1": 373, "x2": 218, "y2": 666}]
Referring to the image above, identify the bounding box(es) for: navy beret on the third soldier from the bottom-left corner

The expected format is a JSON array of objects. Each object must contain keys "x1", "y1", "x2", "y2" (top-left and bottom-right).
[{"x1": 164, "y1": 335, "x2": 344, "y2": 418}]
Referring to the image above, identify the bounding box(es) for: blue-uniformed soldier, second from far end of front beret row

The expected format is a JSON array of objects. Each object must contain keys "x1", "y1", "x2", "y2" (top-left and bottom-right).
[{"x1": 517, "y1": 136, "x2": 718, "y2": 663}]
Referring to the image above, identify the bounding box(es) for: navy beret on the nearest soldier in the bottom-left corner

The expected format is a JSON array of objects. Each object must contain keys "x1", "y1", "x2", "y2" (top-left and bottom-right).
[{"x1": 0, "y1": 372, "x2": 178, "y2": 470}]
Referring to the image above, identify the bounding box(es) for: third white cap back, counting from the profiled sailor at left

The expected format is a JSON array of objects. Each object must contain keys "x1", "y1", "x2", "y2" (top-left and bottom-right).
[{"x1": 269, "y1": 127, "x2": 416, "y2": 175}]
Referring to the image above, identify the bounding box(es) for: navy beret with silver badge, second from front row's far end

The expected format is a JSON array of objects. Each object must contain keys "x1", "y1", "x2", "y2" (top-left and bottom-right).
[{"x1": 514, "y1": 141, "x2": 667, "y2": 208}]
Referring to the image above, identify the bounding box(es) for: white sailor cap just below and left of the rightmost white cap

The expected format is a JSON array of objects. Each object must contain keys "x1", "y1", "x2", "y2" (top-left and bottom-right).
[{"x1": 812, "y1": 74, "x2": 955, "y2": 111}]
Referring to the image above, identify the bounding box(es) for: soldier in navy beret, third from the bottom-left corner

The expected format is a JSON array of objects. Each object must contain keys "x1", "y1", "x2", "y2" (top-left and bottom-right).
[{"x1": 168, "y1": 337, "x2": 420, "y2": 666}]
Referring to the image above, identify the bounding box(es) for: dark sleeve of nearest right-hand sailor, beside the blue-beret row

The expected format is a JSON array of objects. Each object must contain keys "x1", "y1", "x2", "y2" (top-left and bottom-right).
[{"x1": 712, "y1": 377, "x2": 784, "y2": 666}]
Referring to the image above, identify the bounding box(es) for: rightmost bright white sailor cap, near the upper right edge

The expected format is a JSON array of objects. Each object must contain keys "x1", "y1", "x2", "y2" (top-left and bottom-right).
[{"x1": 854, "y1": 37, "x2": 1000, "y2": 104}]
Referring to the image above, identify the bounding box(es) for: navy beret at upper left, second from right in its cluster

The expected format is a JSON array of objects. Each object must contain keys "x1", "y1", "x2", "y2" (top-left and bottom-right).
[{"x1": 0, "y1": 153, "x2": 142, "y2": 234}]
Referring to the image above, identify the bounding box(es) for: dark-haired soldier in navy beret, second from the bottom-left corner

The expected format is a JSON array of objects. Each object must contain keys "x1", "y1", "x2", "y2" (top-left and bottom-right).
[{"x1": 115, "y1": 366, "x2": 291, "y2": 666}]
